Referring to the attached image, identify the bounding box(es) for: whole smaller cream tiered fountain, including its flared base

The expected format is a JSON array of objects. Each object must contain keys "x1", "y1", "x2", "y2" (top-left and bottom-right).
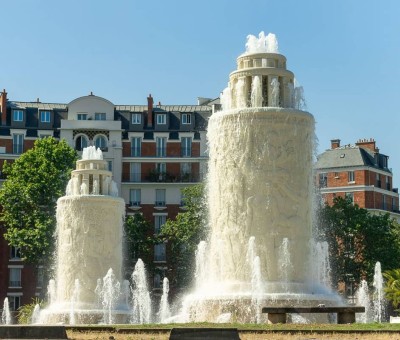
[{"x1": 41, "y1": 147, "x2": 129, "y2": 324}]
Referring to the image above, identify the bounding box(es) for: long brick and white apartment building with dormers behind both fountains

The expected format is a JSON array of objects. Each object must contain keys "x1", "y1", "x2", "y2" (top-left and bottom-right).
[{"x1": 0, "y1": 90, "x2": 219, "y2": 310}]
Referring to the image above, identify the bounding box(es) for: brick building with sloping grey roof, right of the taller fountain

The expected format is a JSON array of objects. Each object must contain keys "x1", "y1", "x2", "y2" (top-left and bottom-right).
[{"x1": 315, "y1": 139, "x2": 400, "y2": 220}]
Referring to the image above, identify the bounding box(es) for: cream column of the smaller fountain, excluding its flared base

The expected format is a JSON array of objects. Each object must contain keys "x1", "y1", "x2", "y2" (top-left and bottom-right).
[{"x1": 56, "y1": 147, "x2": 125, "y2": 309}]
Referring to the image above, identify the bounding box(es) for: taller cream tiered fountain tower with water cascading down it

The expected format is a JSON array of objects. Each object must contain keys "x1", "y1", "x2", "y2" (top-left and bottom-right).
[{"x1": 184, "y1": 32, "x2": 338, "y2": 321}]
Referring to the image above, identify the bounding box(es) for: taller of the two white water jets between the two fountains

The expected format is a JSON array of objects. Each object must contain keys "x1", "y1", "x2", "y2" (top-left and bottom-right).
[{"x1": 132, "y1": 259, "x2": 151, "y2": 324}]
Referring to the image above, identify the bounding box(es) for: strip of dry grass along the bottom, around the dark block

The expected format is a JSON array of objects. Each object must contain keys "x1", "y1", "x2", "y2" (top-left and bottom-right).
[{"x1": 67, "y1": 323, "x2": 400, "y2": 340}]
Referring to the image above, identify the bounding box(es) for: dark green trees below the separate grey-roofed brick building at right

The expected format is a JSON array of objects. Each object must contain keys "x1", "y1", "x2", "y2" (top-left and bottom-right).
[{"x1": 318, "y1": 197, "x2": 400, "y2": 284}]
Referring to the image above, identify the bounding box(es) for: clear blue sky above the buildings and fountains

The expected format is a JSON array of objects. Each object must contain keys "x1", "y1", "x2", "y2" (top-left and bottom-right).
[{"x1": 0, "y1": 0, "x2": 400, "y2": 187}]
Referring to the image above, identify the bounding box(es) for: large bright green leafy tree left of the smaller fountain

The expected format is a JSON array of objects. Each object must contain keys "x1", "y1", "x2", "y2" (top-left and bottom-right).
[{"x1": 0, "y1": 137, "x2": 77, "y2": 262}]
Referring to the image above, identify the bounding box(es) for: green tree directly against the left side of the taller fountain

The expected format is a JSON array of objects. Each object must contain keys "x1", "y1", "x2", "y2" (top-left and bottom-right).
[{"x1": 159, "y1": 184, "x2": 207, "y2": 289}]
